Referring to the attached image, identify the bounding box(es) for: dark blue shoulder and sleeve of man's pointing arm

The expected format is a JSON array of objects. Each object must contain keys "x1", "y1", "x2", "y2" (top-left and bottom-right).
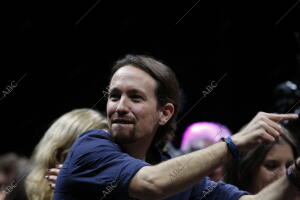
[{"x1": 54, "y1": 130, "x2": 150, "y2": 197}]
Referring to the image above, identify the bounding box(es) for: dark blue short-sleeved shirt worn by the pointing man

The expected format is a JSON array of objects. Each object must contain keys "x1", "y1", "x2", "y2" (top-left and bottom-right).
[{"x1": 54, "y1": 129, "x2": 247, "y2": 200}]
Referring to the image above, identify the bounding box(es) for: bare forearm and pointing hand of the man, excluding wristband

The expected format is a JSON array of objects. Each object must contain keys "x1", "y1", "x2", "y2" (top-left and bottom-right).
[{"x1": 129, "y1": 112, "x2": 298, "y2": 200}]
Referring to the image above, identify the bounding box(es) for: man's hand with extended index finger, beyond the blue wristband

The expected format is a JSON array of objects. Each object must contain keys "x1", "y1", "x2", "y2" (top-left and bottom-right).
[{"x1": 232, "y1": 112, "x2": 298, "y2": 151}]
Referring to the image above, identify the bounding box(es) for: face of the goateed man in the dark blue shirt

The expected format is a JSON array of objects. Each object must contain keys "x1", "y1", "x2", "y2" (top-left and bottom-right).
[{"x1": 106, "y1": 65, "x2": 159, "y2": 144}]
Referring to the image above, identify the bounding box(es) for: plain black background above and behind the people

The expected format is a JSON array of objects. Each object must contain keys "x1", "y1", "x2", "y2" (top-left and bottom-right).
[{"x1": 0, "y1": 0, "x2": 300, "y2": 156}]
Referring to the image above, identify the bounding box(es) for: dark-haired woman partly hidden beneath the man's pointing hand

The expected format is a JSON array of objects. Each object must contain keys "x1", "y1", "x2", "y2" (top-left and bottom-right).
[{"x1": 224, "y1": 127, "x2": 299, "y2": 199}]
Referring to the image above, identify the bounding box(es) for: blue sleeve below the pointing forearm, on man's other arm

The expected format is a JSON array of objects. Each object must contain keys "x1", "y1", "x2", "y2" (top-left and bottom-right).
[{"x1": 191, "y1": 177, "x2": 249, "y2": 200}]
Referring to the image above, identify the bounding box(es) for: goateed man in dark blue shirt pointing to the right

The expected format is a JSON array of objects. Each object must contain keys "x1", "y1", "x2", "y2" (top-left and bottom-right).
[{"x1": 54, "y1": 55, "x2": 300, "y2": 200}]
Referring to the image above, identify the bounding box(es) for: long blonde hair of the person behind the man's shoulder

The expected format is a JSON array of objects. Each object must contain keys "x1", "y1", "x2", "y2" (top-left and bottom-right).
[{"x1": 25, "y1": 108, "x2": 108, "y2": 200}]
